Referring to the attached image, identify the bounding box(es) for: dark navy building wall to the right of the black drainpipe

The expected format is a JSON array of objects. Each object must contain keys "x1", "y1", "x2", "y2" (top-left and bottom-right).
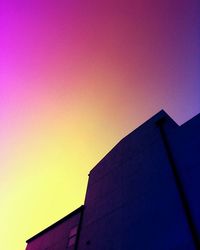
[{"x1": 168, "y1": 114, "x2": 200, "y2": 238}]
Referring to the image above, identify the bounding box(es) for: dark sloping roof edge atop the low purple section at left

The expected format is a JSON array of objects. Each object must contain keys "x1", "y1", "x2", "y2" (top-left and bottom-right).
[{"x1": 26, "y1": 205, "x2": 84, "y2": 243}]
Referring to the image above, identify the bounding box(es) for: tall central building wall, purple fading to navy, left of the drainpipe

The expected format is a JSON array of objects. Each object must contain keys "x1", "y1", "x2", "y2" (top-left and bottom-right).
[{"x1": 78, "y1": 112, "x2": 195, "y2": 250}]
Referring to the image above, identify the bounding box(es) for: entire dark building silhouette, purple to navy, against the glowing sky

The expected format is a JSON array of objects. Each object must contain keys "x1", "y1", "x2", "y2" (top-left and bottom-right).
[{"x1": 26, "y1": 111, "x2": 200, "y2": 250}]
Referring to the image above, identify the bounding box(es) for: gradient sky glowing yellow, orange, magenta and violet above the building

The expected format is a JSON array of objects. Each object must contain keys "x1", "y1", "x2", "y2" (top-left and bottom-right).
[{"x1": 0, "y1": 0, "x2": 200, "y2": 250}]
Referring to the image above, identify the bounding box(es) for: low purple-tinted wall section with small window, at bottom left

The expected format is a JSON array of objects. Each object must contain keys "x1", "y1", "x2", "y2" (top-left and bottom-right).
[{"x1": 26, "y1": 209, "x2": 82, "y2": 250}]
